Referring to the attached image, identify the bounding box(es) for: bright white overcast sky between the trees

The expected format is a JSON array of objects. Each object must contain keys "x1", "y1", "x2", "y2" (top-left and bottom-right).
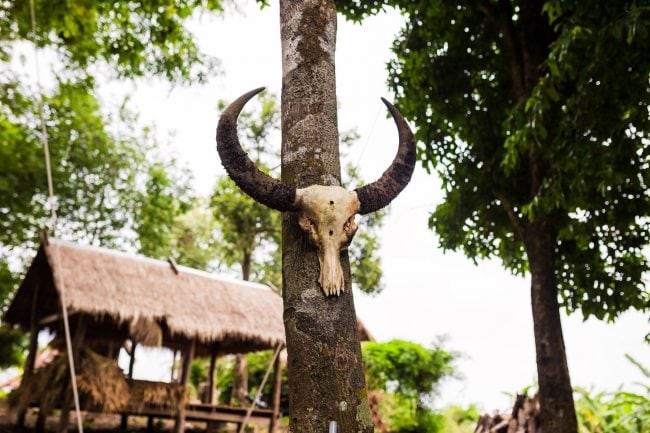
[{"x1": 43, "y1": 1, "x2": 650, "y2": 410}]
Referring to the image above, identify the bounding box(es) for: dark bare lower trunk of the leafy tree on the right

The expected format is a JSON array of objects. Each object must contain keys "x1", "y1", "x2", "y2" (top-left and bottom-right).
[{"x1": 526, "y1": 217, "x2": 578, "y2": 433}]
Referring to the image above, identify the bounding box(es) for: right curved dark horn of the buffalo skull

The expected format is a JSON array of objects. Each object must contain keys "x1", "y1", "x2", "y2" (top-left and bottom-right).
[{"x1": 355, "y1": 98, "x2": 415, "y2": 215}]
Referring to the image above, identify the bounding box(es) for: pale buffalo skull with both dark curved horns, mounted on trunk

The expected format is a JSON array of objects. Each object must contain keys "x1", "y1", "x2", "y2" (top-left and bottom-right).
[{"x1": 217, "y1": 88, "x2": 415, "y2": 296}]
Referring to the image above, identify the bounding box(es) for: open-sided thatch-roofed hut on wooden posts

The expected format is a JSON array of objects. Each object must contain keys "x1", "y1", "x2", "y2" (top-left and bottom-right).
[{"x1": 3, "y1": 238, "x2": 284, "y2": 431}]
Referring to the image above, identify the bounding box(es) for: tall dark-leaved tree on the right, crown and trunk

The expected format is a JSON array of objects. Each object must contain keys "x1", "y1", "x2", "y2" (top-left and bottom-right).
[{"x1": 337, "y1": 0, "x2": 650, "y2": 433}]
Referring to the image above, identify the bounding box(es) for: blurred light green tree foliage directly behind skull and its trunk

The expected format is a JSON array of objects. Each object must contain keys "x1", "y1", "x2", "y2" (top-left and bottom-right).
[{"x1": 210, "y1": 94, "x2": 385, "y2": 293}]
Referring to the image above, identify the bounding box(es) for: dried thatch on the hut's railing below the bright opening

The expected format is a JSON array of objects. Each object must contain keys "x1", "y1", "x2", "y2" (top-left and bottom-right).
[{"x1": 128, "y1": 380, "x2": 187, "y2": 415}]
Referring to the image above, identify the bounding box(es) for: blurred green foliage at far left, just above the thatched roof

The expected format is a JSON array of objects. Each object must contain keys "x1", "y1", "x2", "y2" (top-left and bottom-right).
[{"x1": 0, "y1": 74, "x2": 195, "y2": 304}]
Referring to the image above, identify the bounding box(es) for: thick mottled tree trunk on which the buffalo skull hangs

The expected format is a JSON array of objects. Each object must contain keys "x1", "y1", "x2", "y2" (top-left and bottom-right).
[{"x1": 280, "y1": 0, "x2": 373, "y2": 433}]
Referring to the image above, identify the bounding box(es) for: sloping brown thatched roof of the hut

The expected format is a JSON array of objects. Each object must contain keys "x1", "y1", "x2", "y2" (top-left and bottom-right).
[{"x1": 4, "y1": 238, "x2": 284, "y2": 352}]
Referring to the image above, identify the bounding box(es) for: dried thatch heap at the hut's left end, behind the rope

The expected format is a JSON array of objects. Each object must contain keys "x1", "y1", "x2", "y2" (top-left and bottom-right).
[{"x1": 9, "y1": 349, "x2": 129, "y2": 412}]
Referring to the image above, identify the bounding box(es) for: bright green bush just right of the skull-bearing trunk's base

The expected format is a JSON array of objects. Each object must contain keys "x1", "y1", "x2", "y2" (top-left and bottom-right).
[{"x1": 363, "y1": 340, "x2": 454, "y2": 433}]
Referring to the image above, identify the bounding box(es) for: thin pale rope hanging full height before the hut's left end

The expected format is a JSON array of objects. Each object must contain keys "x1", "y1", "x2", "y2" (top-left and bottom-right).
[{"x1": 29, "y1": 0, "x2": 83, "y2": 433}]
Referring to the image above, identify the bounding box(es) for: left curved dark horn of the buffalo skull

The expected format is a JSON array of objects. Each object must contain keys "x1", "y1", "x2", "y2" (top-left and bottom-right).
[{"x1": 217, "y1": 87, "x2": 297, "y2": 212}]
